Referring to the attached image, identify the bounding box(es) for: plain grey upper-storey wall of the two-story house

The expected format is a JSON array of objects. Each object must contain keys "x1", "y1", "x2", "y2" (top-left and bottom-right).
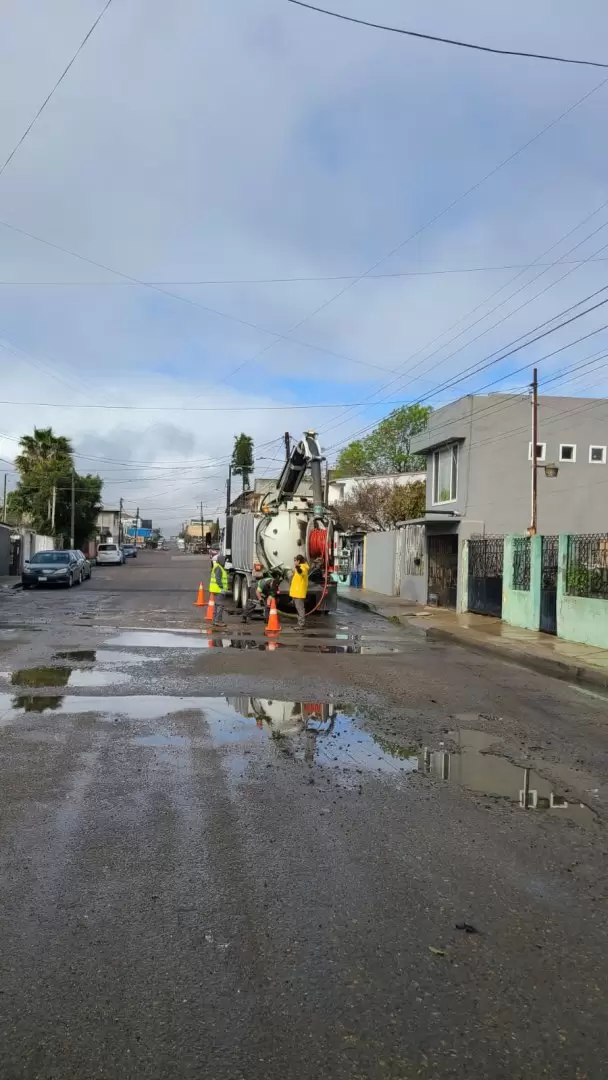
[{"x1": 411, "y1": 394, "x2": 608, "y2": 537}]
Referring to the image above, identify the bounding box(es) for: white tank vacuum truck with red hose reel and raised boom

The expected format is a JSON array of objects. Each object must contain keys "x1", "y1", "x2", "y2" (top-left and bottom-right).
[{"x1": 224, "y1": 431, "x2": 337, "y2": 612}]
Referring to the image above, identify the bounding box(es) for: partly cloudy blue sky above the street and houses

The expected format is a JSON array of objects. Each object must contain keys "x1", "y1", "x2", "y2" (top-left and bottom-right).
[{"x1": 0, "y1": 0, "x2": 608, "y2": 534}]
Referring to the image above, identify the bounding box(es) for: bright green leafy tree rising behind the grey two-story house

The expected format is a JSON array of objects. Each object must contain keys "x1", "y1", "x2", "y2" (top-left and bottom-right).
[{"x1": 335, "y1": 405, "x2": 432, "y2": 476}]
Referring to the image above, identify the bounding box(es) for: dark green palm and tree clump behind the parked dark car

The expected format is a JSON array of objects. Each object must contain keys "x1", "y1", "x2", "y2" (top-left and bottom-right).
[{"x1": 8, "y1": 428, "x2": 104, "y2": 546}]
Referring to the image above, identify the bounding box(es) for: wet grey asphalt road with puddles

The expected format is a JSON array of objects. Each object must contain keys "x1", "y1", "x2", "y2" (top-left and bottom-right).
[{"x1": 0, "y1": 552, "x2": 608, "y2": 1080}]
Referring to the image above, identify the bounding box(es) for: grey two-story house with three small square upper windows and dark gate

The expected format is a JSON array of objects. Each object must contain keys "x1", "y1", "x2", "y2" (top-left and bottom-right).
[{"x1": 404, "y1": 393, "x2": 608, "y2": 607}]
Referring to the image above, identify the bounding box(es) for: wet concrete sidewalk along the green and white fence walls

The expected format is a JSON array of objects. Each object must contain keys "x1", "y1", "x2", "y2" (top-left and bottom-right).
[{"x1": 338, "y1": 589, "x2": 608, "y2": 689}]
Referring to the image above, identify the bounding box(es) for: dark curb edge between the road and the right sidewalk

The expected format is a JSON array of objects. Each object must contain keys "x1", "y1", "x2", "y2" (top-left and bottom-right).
[{"x1": 338, "y1": 594, "x2": 608, "y2": 690}]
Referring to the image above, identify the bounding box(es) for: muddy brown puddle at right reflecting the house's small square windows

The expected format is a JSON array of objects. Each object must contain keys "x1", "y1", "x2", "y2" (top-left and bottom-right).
[{"x1": 420, "y1": 728, "x2": 596, "y2": 826}]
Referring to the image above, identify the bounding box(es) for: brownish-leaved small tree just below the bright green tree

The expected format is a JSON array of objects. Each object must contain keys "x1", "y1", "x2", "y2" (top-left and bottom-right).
[{"x1": 333, "y1": 481, "x2": 427, "y2": 532}]
